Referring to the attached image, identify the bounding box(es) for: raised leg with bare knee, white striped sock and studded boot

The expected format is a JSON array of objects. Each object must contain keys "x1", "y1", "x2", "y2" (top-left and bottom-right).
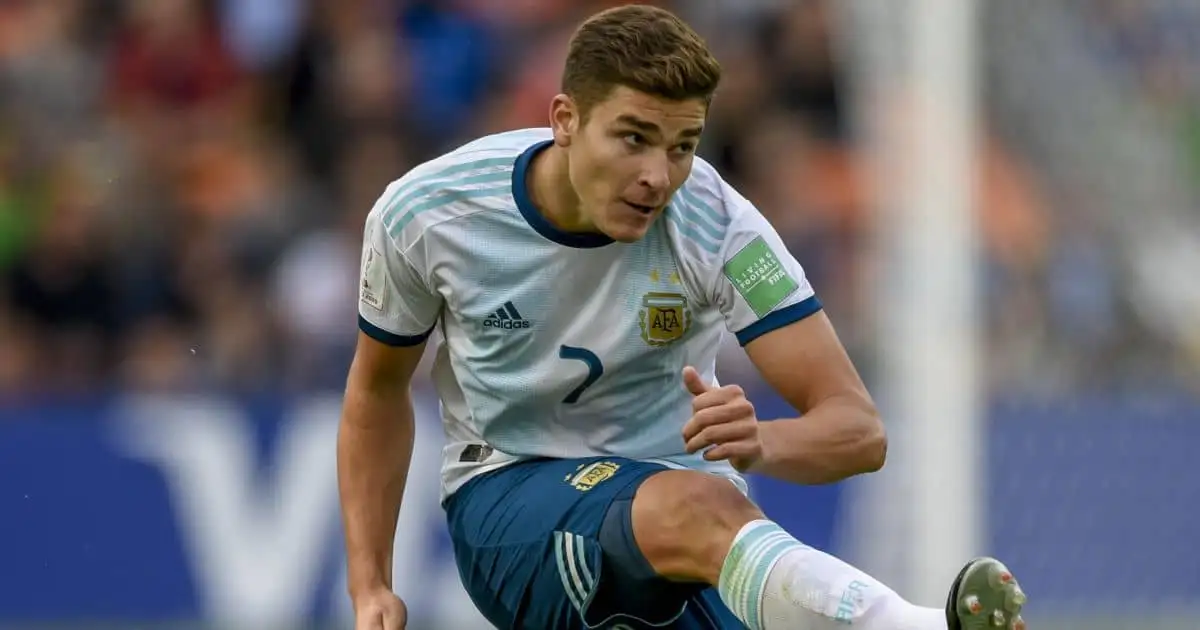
[{"x1": 631, "y1": 470, "x2": 1025, "y2": 630}]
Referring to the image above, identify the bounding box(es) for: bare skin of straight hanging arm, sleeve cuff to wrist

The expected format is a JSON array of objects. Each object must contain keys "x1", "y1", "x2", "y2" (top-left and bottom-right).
[{"x1": 337, "y1": 332, "x2": 425, "y2": 600}]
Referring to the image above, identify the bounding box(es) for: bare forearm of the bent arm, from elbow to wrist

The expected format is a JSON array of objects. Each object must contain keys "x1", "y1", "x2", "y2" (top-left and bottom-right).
[{"x1": 751, "y1": 400, "x2": 887, "y2": 485}]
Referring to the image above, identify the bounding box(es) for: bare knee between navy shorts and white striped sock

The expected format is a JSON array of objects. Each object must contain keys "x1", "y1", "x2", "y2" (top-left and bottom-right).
[{"x1": 632, "y1": 470, "x2": 763, "y2": 584}]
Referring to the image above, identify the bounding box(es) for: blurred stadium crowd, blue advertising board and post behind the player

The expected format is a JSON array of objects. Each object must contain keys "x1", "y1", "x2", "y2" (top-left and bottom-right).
[{"x1": 0, "y1": 0, "x2": 1200, "y2": 630}]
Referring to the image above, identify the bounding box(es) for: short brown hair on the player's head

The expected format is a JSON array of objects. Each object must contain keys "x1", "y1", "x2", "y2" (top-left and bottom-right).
[{"x1": 563, "y1": 5, "x2": 721, "y2": 116}]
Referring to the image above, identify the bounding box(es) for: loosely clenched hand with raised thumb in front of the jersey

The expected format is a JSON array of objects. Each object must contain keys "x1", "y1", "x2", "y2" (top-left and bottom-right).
[{"x1": 683, "y1": 366, "x2": 762, "y2": 472}]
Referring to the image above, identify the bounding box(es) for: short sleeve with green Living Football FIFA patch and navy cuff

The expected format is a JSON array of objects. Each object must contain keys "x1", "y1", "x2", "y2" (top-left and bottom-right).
[{"x1": 709, "y1": 182, "x2": 821, "y2": 346}]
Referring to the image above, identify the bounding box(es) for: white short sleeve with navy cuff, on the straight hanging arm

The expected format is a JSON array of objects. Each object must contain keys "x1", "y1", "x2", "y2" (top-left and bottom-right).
[{"x1": 359, "y1": 211, "x2": 442, "y2": 346}]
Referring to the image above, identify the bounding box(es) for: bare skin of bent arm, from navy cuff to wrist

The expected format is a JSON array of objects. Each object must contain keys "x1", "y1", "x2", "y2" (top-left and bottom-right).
[{"x1": 745, "y1": 311, "x2": 888, "y2": 484}]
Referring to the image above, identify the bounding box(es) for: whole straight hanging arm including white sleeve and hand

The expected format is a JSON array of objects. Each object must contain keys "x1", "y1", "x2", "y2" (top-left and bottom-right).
[{"x1": 337, "y1": 190, "x2": 444, "y2": 614}]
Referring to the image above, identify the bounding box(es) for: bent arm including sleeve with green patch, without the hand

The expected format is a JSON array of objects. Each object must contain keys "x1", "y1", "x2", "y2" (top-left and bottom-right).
[{"x1": 694, "y1": 167, "x2": 887, "y2": 484}]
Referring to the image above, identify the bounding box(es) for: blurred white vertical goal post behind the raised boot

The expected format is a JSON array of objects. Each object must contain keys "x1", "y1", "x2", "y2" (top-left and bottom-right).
[{"x1": 902, "y1": 0, "x2": 988, "y2": 604}]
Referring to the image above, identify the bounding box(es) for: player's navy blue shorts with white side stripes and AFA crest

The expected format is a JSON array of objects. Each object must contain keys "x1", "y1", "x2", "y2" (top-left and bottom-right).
[{"x1": 445, "y1": 457, "x2": 745, "y2": 630}]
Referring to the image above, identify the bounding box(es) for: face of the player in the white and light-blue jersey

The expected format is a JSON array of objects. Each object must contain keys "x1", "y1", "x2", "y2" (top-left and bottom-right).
[{"x1": 568, "y1": 86, "x2": 708, "y2": 242}]
